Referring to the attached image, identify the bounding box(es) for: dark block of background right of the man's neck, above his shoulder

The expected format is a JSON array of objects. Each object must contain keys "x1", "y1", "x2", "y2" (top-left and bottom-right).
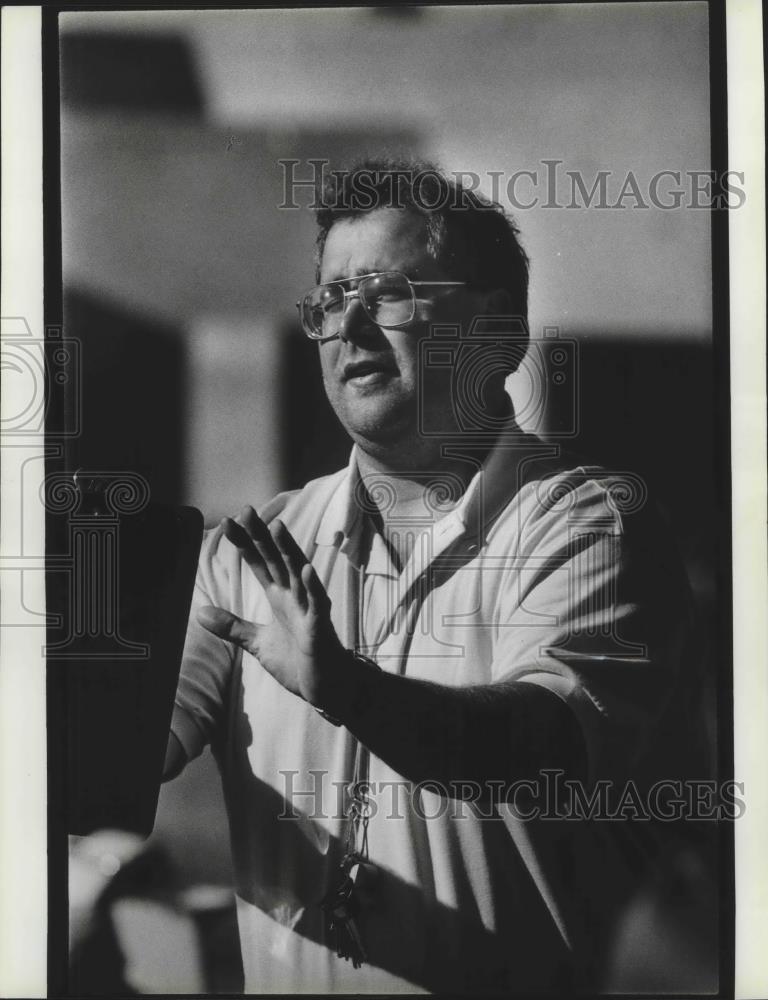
[{"x1": 550, "y1": 331, "x2": 723, "y2": 610}]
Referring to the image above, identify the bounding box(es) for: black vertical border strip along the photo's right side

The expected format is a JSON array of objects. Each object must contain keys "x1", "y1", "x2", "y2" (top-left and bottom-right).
[{"x1": 709, "y1": 0, "x2": 736, "y2": 996}]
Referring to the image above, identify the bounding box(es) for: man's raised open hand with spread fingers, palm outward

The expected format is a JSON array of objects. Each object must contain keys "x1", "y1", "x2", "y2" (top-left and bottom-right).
[{"x1": 198, "y1": 507, "x2": 347, "y2": 707}]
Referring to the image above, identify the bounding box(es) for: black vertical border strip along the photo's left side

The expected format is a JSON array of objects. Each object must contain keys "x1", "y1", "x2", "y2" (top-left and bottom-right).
[{"x1": 42, "y1": 6, "x2": 68, "y2": 996}]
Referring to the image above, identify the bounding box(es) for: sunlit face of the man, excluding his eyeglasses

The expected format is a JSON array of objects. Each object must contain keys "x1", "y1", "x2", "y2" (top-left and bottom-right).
[{"x1": 320, "y1": 208, "x2": 466, "y2": 448}]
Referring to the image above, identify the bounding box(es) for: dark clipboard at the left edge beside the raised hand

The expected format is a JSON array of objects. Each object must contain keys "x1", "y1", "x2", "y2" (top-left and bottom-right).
[{"x1": 46, "y1": 486, "x2": 203, "y2": 836}]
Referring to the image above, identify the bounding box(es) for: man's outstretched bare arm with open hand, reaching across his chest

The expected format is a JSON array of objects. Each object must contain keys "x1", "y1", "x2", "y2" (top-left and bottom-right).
[{"x1": 198, "y1": 508, "x2": 586, "y2": 790}]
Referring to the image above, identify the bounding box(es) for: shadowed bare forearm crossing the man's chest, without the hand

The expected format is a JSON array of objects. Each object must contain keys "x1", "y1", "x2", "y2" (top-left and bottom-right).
[{"x1": 323, "y1": 655, "x2": 586, "y2": 792}]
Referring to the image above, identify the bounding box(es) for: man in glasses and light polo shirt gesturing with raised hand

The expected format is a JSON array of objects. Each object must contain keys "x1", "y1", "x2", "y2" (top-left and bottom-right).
[{"x1": 162, "y1": 163, "x2": 704, "y2": 993}]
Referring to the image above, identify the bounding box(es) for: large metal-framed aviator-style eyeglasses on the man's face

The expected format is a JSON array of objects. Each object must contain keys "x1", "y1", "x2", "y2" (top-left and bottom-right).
[{"x1": 296, "y1": 271, "x2": 466, "y2": 340}]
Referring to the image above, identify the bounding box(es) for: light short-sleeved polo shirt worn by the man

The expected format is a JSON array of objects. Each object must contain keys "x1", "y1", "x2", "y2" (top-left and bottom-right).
[{"x1": 172, "y1": 435, "x2": 690, "y2": 993}]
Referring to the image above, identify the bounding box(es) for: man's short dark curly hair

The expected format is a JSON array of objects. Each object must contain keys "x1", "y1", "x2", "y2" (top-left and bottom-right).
[{"x1": 315, "y1": 158, "x2": 528, "y2": 324}]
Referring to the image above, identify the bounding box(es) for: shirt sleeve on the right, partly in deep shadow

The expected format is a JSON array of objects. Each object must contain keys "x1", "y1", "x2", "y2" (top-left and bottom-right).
[{"x1": 492, "y1": 476, "x2": 691, "y2": 778}]
